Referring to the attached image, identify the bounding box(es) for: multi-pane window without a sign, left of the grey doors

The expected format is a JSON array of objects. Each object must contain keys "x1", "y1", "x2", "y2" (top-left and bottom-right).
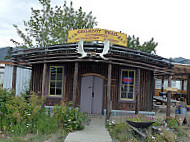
[{"x1": 49, "y1": 66, "x2": 64, "y2": 97}]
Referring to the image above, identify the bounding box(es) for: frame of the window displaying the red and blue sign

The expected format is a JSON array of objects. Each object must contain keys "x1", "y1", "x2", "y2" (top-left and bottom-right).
[{"x1": 118, "y1": 68, "x2": 137, "y2": 103}]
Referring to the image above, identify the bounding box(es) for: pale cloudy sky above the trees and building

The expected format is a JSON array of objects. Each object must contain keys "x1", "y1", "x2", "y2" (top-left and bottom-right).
[{"x1": 0, "y1": 0, "x2": 190, "y2": 59}]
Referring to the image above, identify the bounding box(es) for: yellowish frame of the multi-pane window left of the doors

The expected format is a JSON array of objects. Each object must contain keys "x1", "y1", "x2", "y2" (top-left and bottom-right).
[{"x1": 47, "y1": 65, "x2": 65, "y2": 98}]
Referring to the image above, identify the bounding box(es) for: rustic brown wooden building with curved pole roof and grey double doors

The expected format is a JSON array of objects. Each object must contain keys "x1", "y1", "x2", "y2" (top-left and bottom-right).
[{"x1": 12, "y1": 43, "x2": 172, "y2": 117}]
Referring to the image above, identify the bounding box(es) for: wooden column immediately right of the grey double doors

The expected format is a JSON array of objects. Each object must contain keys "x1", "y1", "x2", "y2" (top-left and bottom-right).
[{"x1": 106, "y1": 63, "x2": 112, "y2": 121}]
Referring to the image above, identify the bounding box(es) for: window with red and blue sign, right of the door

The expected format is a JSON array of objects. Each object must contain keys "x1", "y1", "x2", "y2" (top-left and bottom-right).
[{"x1": 120, "y1": 69, "x2": 135, "y2": 101}]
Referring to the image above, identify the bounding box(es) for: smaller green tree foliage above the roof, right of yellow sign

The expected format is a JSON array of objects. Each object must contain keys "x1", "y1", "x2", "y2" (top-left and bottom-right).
[{"x1": 127, "y1": 35, "x2": 158, "y2": 53}]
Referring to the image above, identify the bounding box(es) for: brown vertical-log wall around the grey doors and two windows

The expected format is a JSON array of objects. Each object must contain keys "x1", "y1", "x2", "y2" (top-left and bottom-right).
[{"x1": 31, "y1": 62, "x2": 154, "y2": 110}]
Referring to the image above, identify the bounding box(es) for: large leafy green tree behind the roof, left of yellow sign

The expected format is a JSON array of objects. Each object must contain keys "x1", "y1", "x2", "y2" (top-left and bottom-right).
[{"x1": 11, "y1": 0, "x2": 97, "y2": 48}]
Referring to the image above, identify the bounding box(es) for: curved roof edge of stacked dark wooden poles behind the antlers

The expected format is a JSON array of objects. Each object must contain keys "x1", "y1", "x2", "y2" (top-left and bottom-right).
[{"x1": 11, "y1": 43, "x2": 172, "y2": 74}]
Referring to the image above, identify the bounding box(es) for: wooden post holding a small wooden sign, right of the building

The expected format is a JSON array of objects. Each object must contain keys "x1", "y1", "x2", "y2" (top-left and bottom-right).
[{"x1": 166, "y1": 75, "x2": 172, "y2": 116}]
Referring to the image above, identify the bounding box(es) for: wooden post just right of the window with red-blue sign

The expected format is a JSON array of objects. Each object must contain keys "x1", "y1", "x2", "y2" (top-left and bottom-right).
[{"x1": 135, "y1": 68, "x2": 141, "y2": 114}]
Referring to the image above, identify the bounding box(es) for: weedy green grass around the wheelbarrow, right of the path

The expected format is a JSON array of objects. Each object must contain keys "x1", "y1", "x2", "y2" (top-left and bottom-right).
[{"x1": 106, "y1": 119, "x2": 190, "y2": 142}]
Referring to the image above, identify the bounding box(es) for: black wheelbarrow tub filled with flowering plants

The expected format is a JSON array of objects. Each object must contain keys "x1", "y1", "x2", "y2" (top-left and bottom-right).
[{"x1": 126, "y1": 114, "x2": 155, "y2": 128}]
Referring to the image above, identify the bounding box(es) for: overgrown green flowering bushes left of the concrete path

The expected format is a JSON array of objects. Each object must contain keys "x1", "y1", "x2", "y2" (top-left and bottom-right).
[{"x1": 0, "y1": 88, "x2": 87, "y2": 136}]
